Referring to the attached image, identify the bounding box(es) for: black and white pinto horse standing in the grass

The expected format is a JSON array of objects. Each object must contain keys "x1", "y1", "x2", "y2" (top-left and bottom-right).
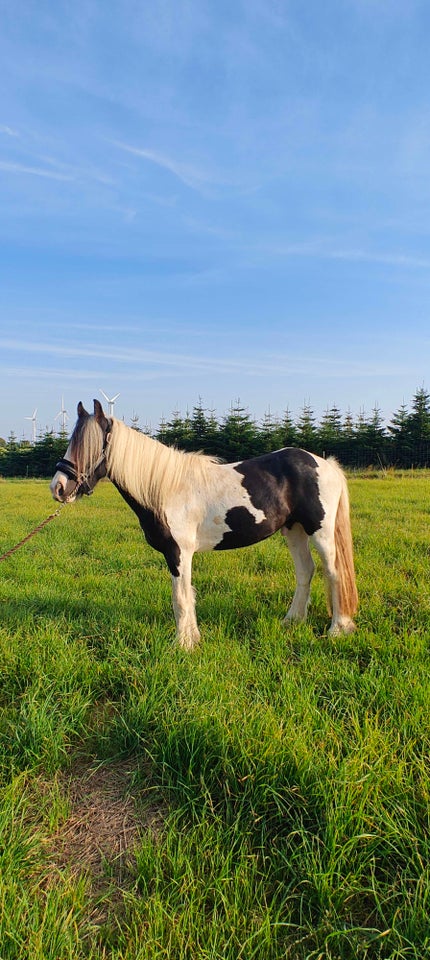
[{"x1": 50, "y1": 400, "x2": 358, "y2": 650}]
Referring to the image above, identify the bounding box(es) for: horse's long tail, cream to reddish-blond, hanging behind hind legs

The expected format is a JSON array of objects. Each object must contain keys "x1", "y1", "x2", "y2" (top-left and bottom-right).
[{"x1": 334, "y1": 468, "x2": 358, "y2": 617}]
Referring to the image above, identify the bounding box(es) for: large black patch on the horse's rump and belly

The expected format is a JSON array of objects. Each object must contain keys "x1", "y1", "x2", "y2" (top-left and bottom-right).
[{"x1": 215, "y1": 447, "x2": 324, "y2": 550}]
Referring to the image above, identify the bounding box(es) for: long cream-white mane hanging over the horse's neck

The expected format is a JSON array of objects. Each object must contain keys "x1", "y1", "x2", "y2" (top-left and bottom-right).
[{"x1": 106, "y1": 418, "x2": 217, "y2": 516}]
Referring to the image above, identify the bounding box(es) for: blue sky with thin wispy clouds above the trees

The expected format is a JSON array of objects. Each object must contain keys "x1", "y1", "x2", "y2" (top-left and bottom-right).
[{"x1": 0, "y1": 0, "x2": 430, "y2": 438}]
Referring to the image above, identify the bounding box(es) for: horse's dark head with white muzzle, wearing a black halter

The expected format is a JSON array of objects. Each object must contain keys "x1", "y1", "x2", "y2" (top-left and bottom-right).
[{"x1": 50, "y1": 400, "x2": 112, "y2": 503}]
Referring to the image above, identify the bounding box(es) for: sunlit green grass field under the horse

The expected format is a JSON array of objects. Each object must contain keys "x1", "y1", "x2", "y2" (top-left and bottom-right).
[{"x1": 0, "y1": 473, "x2": 430, "y2": 960}]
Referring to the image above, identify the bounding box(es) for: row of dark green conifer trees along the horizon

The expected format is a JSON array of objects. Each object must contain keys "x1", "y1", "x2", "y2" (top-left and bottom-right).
[{"x1": 0, "y1": 387, "x2": 430, "y2": 477}]
